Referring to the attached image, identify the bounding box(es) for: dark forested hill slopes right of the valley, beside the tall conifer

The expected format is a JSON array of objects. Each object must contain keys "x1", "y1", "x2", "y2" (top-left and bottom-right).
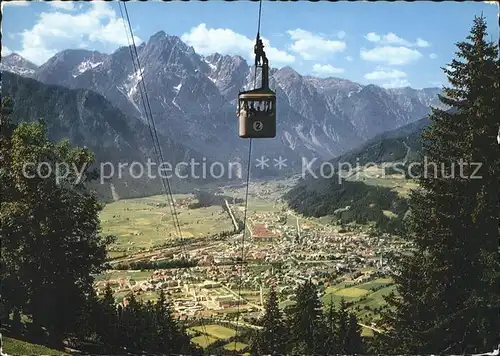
[{"x1": 284, "y1": 118, "x2": 431, "y2": 232}]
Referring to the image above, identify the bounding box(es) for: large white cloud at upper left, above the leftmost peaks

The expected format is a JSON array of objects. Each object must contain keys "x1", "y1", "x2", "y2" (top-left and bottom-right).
[{"x1": 18, "y1": 1, "x2": 142, "y2": 64}]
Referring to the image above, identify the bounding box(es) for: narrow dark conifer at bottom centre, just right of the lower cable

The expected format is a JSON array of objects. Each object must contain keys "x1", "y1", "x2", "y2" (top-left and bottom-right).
[{"x1": 252, "y1": 286, "x2": 286, "y2": 355}]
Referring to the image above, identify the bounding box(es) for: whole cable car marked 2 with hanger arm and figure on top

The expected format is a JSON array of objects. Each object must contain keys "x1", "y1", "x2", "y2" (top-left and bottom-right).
[{"x1": 237, "y1": 35, "x2": 276, "y2": 138}]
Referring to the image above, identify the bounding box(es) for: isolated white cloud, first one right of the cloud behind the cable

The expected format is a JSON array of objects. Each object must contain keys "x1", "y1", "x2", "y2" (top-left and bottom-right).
[{"x1": 287, "y1": 28, "x2": 347, "y2": 60}]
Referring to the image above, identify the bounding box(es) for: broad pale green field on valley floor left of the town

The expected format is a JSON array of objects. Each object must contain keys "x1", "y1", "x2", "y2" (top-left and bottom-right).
[{"x1": 100, "y1": 195, "x2": 233, "y2": 252}]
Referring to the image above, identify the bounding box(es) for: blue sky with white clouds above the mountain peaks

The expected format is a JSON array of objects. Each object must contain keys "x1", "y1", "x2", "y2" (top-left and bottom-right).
[{"x1": 2, "y1": 0, "x2": 498, "y2": 88}]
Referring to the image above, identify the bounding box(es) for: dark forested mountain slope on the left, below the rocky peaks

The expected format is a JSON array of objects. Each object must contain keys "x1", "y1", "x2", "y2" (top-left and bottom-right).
[{"x1": 2, "y1": 72, "x2": 216, "y2": 199}]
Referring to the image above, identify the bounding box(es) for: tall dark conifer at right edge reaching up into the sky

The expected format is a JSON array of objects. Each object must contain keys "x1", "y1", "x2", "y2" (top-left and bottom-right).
[{"x1": 380, "y1": 16, "x2": 500, "y2": 354}]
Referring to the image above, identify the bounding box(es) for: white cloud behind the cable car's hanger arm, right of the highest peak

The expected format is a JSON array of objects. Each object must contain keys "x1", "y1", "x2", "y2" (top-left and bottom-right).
[{"x1": 181, "y1": 23, "x2": 295, "y2": 66}]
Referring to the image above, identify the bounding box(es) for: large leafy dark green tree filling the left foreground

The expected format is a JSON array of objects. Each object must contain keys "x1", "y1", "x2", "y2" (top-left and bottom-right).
[{"x1": 0, "y1": 97, "x2": 112, "y2": 343}]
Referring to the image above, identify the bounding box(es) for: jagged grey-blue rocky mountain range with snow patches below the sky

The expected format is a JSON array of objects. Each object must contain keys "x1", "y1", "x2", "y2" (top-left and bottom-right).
[{"x1": 0, "y1": 31, "x2": 442, "y2": 188}]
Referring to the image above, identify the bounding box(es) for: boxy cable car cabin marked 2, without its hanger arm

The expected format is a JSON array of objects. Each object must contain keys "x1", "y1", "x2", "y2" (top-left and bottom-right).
[{"x1": 238, "y1": 88, "x2": 276, "y2": 138}]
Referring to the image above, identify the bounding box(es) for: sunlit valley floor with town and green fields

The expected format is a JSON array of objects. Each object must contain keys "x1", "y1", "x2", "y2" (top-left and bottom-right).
[{"x1": 95, "y1": 177, "x2": 410, "y2": 349}]
